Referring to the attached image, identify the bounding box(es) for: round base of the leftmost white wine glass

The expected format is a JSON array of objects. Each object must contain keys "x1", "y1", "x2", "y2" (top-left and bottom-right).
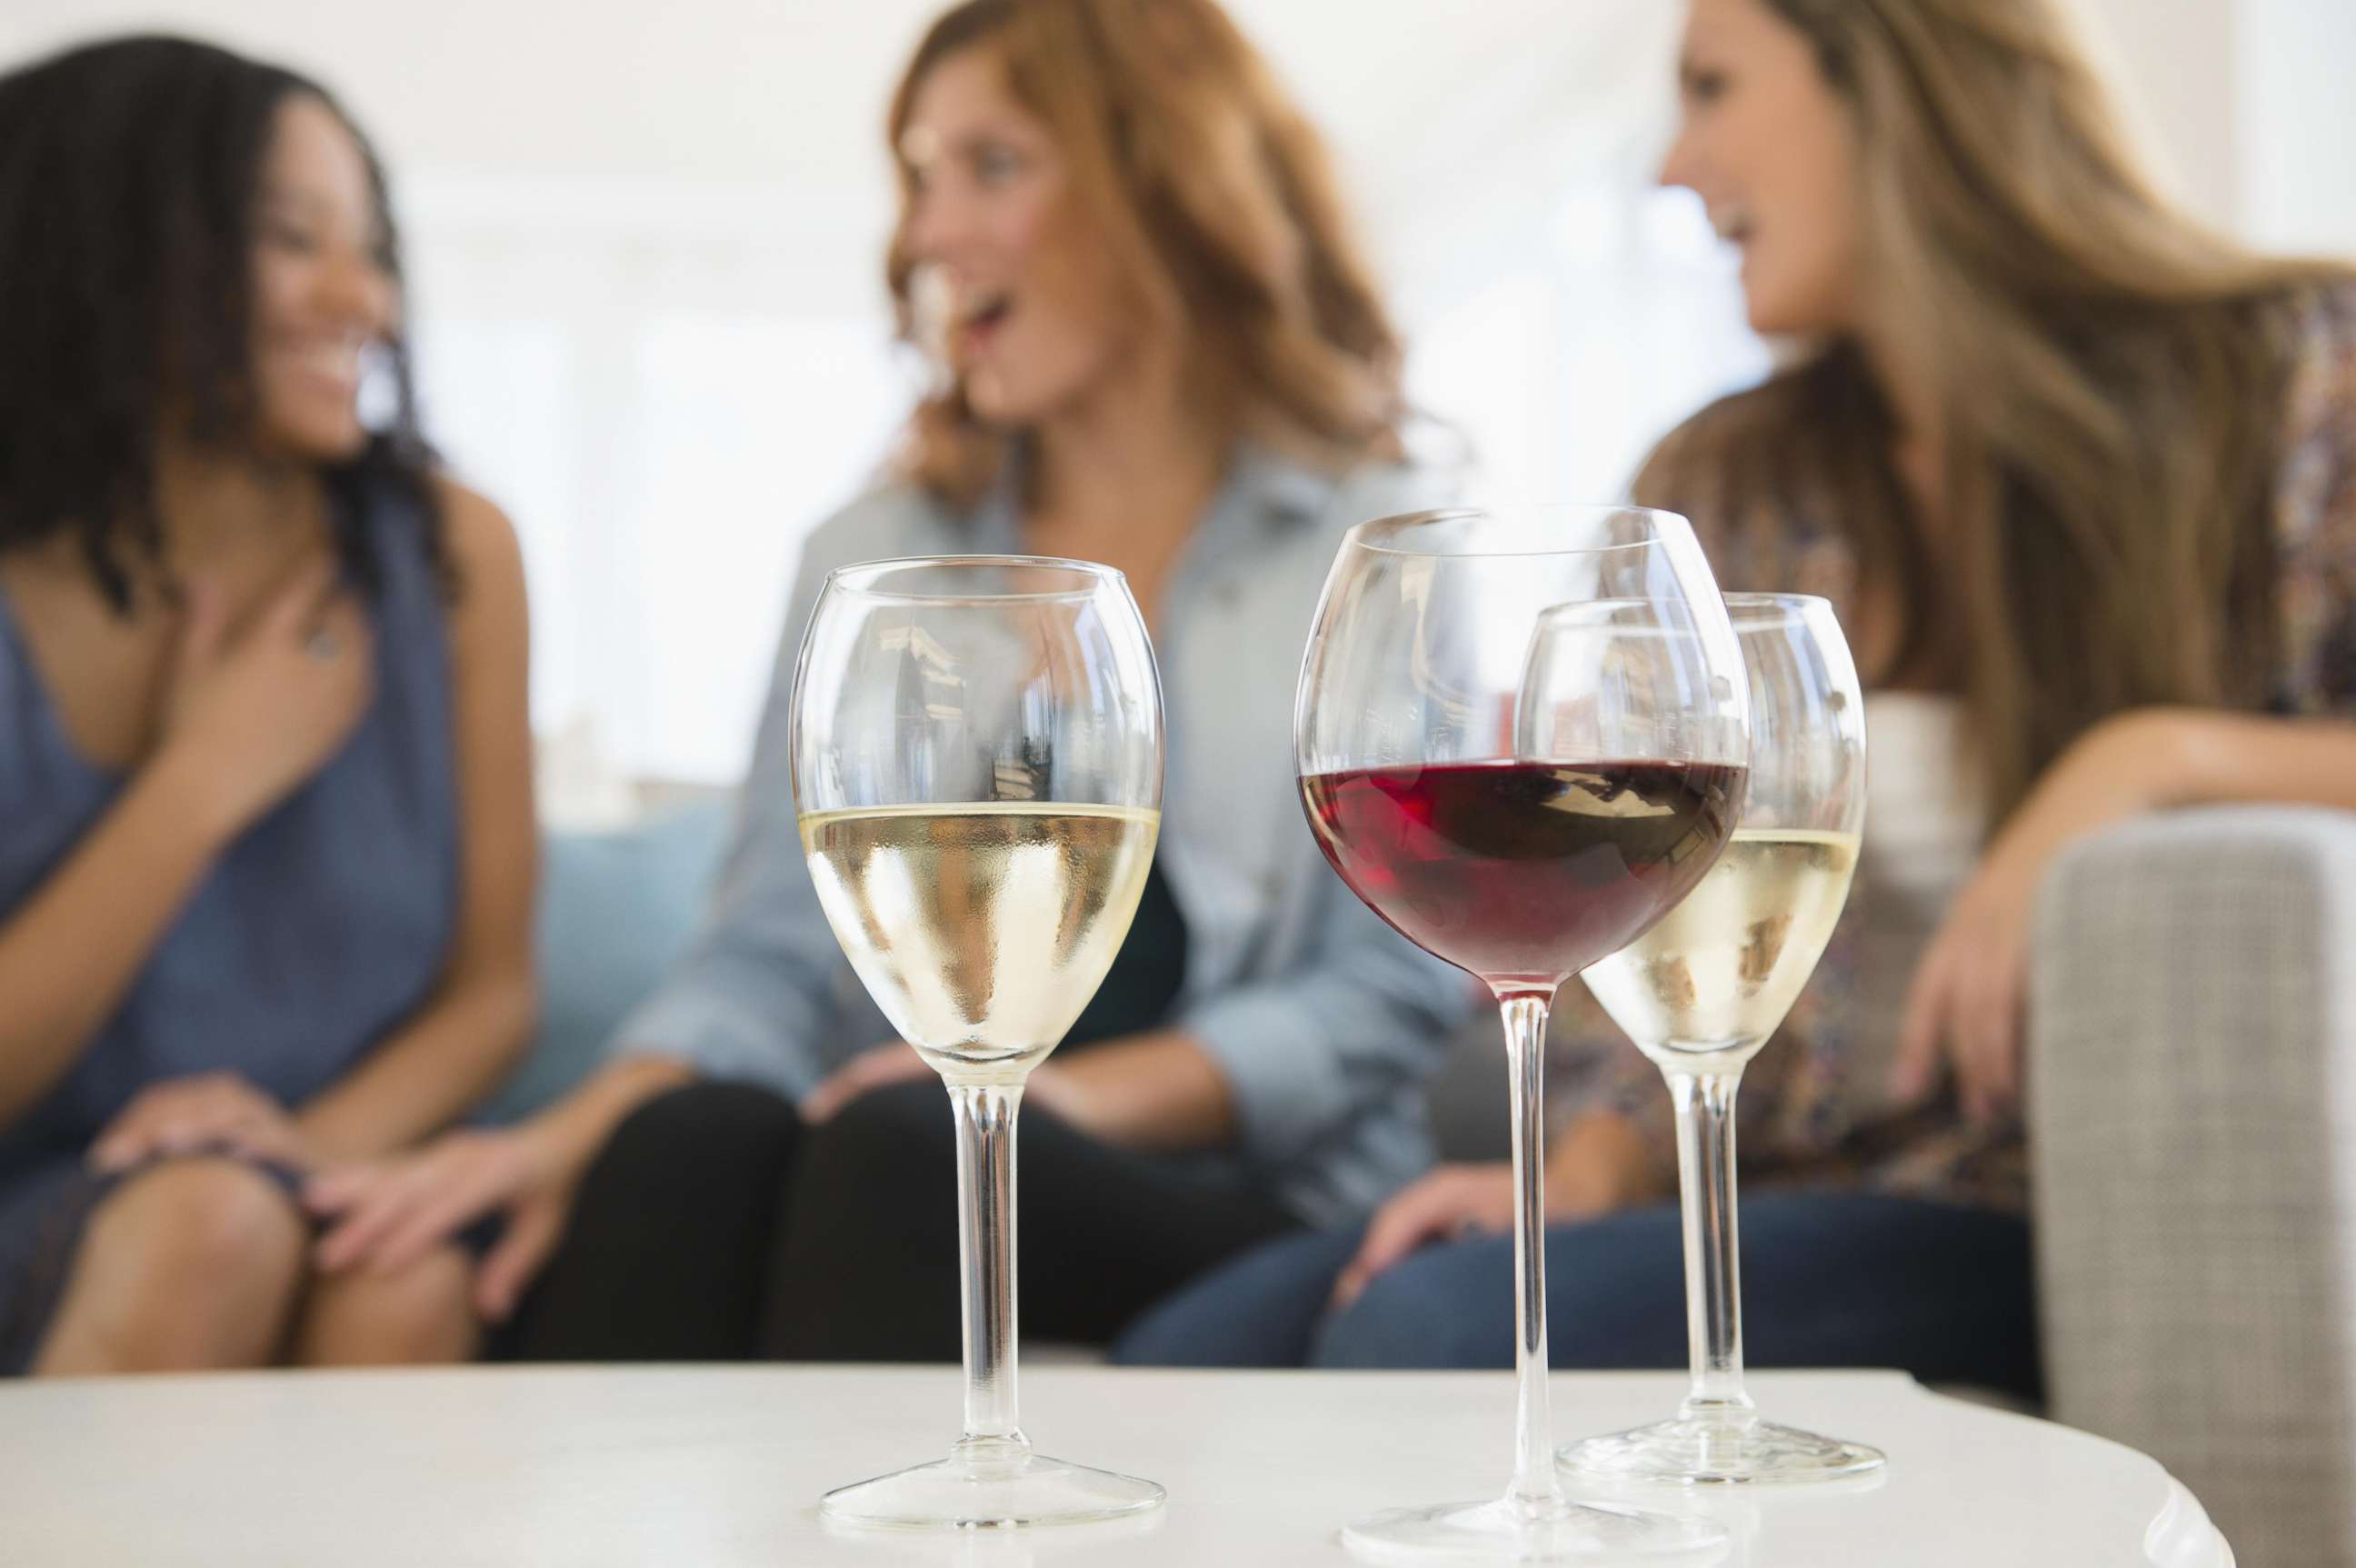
[{"x1": 817, "y1": 1448, "x2": 1162, "y2": 1531}]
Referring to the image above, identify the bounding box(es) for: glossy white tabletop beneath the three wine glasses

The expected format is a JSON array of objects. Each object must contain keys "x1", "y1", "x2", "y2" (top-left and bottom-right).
[{"x1": 0, "y1": 1365, "x2": 2233, "y2": 1568}]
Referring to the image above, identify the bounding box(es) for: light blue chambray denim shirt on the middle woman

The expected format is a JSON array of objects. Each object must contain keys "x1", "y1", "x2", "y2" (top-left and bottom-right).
[{"x1": 613, "y1": 445, "x2": 1472, "y2": 1224}]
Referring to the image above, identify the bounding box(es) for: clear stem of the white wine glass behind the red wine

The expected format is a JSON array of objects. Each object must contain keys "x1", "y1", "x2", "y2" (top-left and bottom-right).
[{"x1": 1663, "y1": 1062, "x2": 1752, "y2": 1417}]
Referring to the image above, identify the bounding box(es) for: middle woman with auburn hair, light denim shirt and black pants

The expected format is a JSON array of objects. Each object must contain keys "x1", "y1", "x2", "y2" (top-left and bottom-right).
[{"x1": 304, "y1": 0, "x2": 1463, "y2": 1358}]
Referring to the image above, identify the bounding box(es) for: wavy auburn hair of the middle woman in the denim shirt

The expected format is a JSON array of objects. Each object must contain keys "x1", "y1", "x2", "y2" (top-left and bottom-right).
[{"x1": 886, "y1": 0, "x2": 1402, "y2": 504}]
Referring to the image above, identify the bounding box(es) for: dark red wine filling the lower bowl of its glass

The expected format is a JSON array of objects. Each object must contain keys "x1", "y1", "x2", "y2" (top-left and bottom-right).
[{"x1": 1301, "y1": 761, "x2": 1748, "y2": 996}]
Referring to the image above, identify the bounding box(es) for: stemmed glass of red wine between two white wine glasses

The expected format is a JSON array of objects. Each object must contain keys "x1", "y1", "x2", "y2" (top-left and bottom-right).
[{"x1": 1293, "y1": 506, "x2": 1751, "y2": 1563}]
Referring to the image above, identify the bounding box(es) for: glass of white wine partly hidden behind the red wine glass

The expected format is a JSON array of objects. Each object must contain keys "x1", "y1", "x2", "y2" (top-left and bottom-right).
[{"x1": 1532, "y1": 594, "x2": 1885, "y2": 1485}]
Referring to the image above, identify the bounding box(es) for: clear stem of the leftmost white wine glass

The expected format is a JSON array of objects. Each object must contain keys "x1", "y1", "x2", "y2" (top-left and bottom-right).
[{"x1": 950, "y1": 1083, "x2": 1030, "y2": 1457}]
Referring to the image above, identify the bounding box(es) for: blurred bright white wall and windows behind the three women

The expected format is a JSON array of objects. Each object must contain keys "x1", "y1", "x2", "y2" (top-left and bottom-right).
[{"x1": 0, "y1": 0, "x2": 2356, "y2": 795}]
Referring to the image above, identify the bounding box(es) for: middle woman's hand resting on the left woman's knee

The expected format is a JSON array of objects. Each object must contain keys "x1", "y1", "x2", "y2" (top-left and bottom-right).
[{"x1": 304, "y1": 1123, "x2": 567, "y2": 1323}]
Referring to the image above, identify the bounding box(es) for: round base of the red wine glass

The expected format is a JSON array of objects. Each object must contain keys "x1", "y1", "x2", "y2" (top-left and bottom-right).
[{"x1": 1341, "y1": 1497, "x2": 1727, "y2": 1563}]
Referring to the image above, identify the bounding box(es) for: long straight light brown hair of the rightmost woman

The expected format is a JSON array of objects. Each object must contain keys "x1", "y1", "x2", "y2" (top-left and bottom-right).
[{"x1": 1637, "y1": 0, "x2": 2351, "y2": 813}]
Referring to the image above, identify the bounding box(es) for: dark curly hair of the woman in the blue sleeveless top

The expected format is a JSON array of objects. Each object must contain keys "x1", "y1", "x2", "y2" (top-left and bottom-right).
[{"x1": 0, "y1": 35, "x2": 447, "y2": 612}]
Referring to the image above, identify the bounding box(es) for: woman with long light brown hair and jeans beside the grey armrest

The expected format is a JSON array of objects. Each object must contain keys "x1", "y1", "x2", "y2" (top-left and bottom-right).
[{"x1": 1122, "y1": 0, "x2": 2356, "y2": 1393}]
